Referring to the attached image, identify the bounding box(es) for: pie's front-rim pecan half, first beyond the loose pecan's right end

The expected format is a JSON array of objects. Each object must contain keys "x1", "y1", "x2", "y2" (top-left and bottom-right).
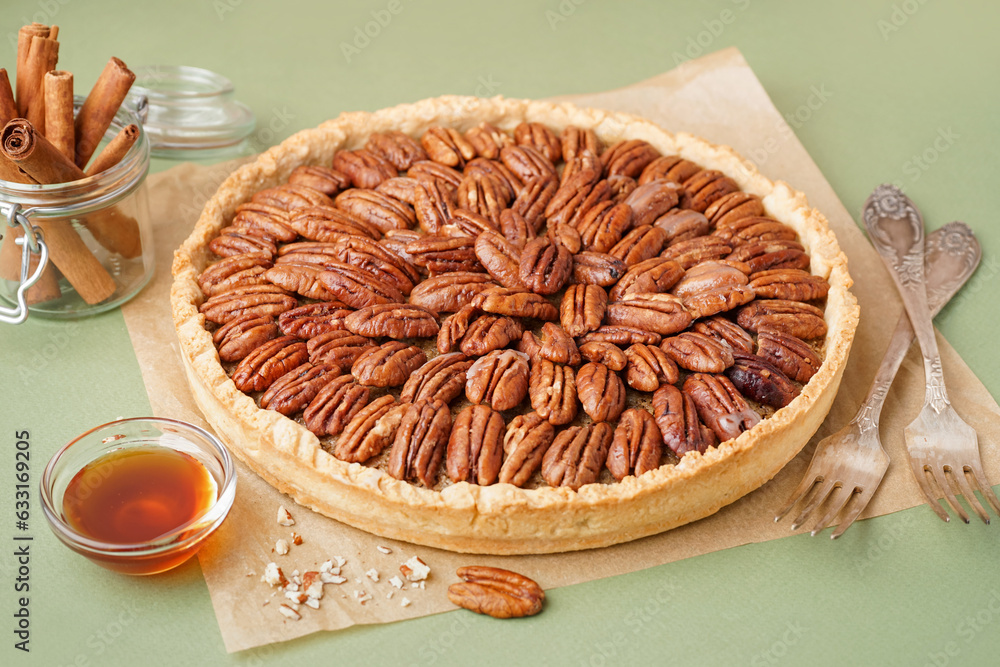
[{"x1": 542, "y1": 422, "x2": 614, "y2": 491}]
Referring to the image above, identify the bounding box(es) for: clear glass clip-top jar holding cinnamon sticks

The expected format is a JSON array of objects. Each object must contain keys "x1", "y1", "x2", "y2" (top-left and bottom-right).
[{"x1": 0, "y1": 96, "x2": 153, "y2": 318}]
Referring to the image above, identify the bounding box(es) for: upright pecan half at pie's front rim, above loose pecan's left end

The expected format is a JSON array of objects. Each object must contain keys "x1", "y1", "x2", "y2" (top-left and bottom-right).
[{"x1": 445, "y1": 405, "x2": 507, "y2": 486}]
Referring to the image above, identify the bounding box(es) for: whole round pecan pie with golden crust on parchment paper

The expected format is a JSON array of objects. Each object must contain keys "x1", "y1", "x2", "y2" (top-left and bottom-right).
[{"x1": 171, "y1": 97, "x2": 858, "y2": 554}]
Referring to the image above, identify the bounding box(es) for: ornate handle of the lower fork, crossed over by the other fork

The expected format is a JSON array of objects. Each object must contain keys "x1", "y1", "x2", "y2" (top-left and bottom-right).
[{"x1": 853, "y1": 222, "x2": 982, "y2": 433}]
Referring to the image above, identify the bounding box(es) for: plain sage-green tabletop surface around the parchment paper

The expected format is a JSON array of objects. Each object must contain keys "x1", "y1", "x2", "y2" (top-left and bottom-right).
[{"x1": 0, "y1": 0, "x2": 1000, "y2": 666}]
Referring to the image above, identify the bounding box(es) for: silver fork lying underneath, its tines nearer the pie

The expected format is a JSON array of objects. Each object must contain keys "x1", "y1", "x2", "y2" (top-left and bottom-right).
[{"x1": 774, "y1": 222, "x2": 982, "y2": 539}]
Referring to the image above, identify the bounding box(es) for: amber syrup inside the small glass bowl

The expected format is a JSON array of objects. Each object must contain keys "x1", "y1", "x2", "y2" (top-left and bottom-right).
[{"x1": 63, "y1": 445, "x2": 218, "y2": 544}]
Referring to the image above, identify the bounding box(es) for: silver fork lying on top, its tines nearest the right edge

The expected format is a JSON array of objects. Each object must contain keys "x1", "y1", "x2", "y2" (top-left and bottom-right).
[{"x1": 864, "y1": 185, "x2": 1000, "y2": 523}]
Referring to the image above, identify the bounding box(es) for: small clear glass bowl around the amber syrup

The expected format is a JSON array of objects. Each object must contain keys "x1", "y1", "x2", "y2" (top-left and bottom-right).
[{"x1": 41, "y1": 417, "x2": 236, "y2": 575}]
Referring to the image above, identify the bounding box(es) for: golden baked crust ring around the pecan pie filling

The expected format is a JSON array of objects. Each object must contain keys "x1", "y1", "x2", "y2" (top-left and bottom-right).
[{"x1": 171, "y1": 96, "x2": 859, "y2": 554}]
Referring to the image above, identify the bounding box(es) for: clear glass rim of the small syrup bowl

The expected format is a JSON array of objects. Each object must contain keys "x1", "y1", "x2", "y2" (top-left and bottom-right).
[{"x1": 39, "y1": 417, "x2": 236, "y2": 558}]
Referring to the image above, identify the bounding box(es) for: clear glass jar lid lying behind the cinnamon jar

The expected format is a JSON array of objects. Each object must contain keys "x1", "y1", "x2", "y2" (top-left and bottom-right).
[{"x1": 129, "y1": 65, "x2": 257, "y2": 159}]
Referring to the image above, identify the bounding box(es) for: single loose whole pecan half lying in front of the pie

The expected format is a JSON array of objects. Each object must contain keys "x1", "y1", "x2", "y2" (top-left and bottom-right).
[{"x1": 448, "y1": 565, "x2": 545, "y2": 618}]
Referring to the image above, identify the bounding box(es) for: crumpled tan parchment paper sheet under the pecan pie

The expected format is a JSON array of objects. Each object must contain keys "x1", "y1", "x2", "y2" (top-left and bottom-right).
[{"x1": 124, "y1": 49, "x2": 1000, "y2": 651}]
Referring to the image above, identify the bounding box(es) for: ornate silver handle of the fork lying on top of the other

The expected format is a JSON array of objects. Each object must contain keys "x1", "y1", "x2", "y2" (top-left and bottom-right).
[{"x1": 864, "y1": 185, "x2": 951, "y2": 414}]
